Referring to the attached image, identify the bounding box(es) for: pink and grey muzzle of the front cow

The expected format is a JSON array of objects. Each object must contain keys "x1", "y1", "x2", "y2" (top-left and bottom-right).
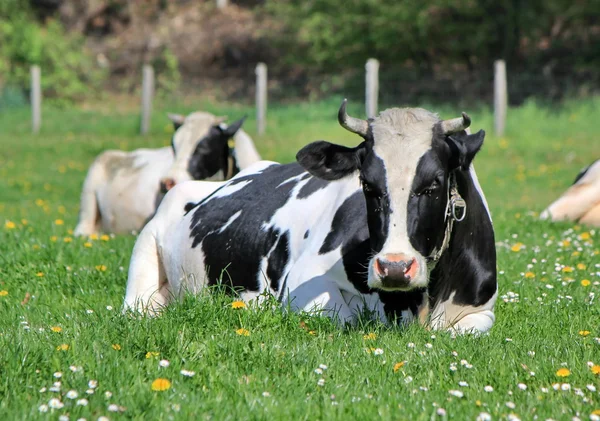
[{"x1": 373, "y1": 254, "x2": 419, "y2": 289}]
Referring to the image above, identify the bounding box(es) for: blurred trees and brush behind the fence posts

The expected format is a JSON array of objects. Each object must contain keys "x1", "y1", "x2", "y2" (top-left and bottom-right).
[{"x1": 0, "y1": 0, "x2": 600, "y2": 106}]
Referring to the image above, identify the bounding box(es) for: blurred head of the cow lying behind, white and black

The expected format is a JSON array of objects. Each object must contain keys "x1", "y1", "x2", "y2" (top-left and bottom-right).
[{"x1": 160, "y1": 112, "x2": 245, "y2": 192}]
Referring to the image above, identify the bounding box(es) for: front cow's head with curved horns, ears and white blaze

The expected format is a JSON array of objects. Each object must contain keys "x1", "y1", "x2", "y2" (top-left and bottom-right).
[{"x1": 297, "y1": 100, "x2": 485, "y2": 291}]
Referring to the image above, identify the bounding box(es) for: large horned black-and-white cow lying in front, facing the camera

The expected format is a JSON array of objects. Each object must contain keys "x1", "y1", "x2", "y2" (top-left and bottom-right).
[{"x1": 124, "y1": 101, "x2": 497, "y2": 332}]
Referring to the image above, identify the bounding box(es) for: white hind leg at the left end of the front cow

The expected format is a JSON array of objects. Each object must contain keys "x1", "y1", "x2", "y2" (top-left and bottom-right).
[{"x1": 123, "y1": 222, "x2": 171, "y2": 315}]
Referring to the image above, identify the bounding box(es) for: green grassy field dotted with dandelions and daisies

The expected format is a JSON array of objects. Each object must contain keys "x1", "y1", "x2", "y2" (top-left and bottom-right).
[{"x1": 0, "y1": 98, "x2": 600, "y2": 420}]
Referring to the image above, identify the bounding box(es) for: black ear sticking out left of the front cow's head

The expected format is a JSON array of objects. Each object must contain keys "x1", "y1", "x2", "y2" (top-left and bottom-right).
[{"x1": 296, "y1": 140, "x2": 365, "y2": 180}]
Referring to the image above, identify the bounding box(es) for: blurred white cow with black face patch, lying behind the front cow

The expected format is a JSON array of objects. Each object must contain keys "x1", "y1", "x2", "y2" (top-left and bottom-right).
[{"x1": 75, "y1": 112, "x2": 260, "y2": 235}]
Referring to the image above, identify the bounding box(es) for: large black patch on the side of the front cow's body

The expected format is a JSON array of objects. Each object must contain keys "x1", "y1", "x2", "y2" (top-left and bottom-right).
[{"x1": 190, "y1": 164, "x2": 304, "y2": 291}]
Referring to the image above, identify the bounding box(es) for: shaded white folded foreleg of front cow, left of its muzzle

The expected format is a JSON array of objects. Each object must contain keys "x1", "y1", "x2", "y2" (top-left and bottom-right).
[{"x1": 282, "y1": 275, "x2": 354, "y2": 325}]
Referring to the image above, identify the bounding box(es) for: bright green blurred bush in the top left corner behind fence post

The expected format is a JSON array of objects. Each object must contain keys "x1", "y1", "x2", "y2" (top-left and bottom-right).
[{"x1": 0, "y1": 0, "x2": 104, "y2": 103}]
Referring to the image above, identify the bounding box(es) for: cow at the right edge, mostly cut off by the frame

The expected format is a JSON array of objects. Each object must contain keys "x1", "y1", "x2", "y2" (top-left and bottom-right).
[{"x1": 540, "y1": 159, "x2": 600, "y2": 227}]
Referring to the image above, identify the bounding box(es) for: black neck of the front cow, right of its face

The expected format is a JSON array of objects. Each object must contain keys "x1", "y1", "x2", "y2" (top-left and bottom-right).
[{"x1": 429, "y1": 166, "x2": 496, "y2": 306}]
